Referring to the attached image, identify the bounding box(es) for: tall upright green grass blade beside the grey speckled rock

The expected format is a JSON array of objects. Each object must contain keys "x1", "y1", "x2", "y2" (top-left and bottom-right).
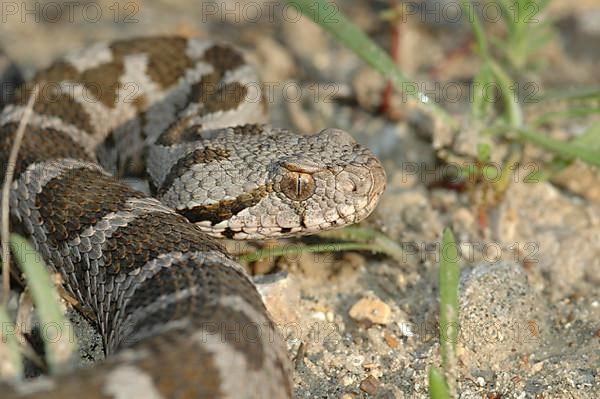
[{"x1": 439, "y1": 228, "x2": 460, "y2": 370}]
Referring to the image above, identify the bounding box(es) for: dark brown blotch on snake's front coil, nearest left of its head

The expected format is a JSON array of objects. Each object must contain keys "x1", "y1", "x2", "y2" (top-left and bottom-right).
[{"x1": 35, "y1": 168, "x2": 144, "y2": 247}]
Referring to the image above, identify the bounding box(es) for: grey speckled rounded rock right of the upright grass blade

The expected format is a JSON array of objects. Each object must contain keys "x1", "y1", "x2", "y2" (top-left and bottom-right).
[{"x1": 459, "y1": 262, "x2": 547, "y2": 370}]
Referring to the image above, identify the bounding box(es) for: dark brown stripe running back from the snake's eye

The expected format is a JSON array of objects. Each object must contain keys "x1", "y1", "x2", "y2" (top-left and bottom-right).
[{"x1": 178, "y1": 186, "x2": 272, "y2": 225}]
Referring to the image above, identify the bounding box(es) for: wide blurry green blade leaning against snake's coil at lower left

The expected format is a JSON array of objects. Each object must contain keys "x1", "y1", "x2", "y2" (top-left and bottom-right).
[{"x1": 10, "y1": 234, "x2": 76, "y2": 372}]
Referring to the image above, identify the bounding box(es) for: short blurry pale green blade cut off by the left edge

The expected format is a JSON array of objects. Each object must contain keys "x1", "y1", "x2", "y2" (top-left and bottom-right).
[{"x1": 0, "y1": 306, "x2": 23, "y2": 379}]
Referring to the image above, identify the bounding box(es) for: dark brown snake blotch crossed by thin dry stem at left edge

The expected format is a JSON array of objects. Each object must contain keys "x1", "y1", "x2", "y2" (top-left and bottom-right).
[{"x1": 0, "y1": 123, "x2": 92, "y2": 180}]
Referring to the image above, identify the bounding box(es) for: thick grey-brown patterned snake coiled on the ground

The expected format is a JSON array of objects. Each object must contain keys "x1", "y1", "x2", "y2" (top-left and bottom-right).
[{"x1": 0, "y1": 36, "x2": 386, "y2": 399}]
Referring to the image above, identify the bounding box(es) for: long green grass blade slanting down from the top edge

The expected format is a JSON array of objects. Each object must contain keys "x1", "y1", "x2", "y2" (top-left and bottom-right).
[{"x1": 286, "y1": 0, "x2": 458, "y2": 129}]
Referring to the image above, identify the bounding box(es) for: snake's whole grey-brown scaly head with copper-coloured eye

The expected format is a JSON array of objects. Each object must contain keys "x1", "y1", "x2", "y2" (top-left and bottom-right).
[{"x1": 154, "y1": 125, "x2": 386, "y2": 239}]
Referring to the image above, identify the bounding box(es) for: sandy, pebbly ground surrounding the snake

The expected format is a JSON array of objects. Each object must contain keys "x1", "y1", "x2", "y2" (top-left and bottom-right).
[{"x1": 0, "y1": 0, "x2": 600, "y2": 399}]
